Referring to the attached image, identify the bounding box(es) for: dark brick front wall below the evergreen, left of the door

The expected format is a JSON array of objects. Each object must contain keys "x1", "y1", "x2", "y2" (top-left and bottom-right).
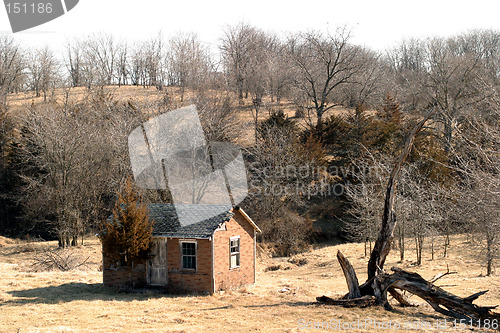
[{"x1": 102, "y1": 253, "x2": 147, "y2": 288}]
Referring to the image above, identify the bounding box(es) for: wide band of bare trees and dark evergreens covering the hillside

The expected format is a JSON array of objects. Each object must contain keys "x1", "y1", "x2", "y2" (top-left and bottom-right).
[{"x1": 0, "y1": 23, "x2": 500, "y2": 274}]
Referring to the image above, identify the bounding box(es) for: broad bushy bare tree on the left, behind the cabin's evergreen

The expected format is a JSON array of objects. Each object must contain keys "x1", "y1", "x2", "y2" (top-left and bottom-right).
[{"x1": 19, "y1": 93, "x2": 137, "y2": 246}]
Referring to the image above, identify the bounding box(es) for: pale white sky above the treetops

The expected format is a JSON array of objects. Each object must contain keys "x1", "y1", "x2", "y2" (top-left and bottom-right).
[{"x1": 0, "y1": 0, "x2": 500, "y2": 56}]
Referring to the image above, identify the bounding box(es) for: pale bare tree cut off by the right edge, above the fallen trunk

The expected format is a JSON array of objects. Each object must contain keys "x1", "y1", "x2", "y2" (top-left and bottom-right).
[{"x1": 454, "y1": 95, "x2": 500, "y2": 275}]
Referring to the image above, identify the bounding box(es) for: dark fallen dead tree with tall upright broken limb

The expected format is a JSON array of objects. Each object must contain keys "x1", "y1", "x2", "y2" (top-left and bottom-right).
[{"x1": 317, "y1": 111, "x2": 500, "y2": 323}]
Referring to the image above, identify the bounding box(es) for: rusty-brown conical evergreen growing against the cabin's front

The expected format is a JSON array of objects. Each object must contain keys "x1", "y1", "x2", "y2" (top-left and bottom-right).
[{"x1": 99, "y1": 178, "x2": 153, "y2": 269}]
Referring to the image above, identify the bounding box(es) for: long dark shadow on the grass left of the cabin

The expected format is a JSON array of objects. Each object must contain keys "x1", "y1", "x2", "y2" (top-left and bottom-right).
[{"x1": 6, "y1": 282, "x2": 193, "y2": 306}]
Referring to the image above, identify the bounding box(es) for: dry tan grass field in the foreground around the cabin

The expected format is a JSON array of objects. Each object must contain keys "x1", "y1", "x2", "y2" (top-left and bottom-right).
[{"x1": 0, "y1": 236, "x2": 500, "y2": 332}]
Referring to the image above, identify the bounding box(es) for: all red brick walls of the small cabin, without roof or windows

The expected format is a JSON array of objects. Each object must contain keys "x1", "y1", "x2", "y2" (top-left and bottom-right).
[{"x1": 103, "y1": 211, "x2": 255, "y2": 292}]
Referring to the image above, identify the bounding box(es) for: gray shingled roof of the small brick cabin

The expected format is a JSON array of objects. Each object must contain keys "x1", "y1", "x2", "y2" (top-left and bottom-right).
[{"x1": 148, "y1": 204, "x2": 234, "y2": 238}]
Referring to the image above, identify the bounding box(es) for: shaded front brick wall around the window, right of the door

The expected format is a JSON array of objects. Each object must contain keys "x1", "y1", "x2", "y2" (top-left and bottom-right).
[{"x1": 167, "y1": 238, "x2": 213, "y2": 292}]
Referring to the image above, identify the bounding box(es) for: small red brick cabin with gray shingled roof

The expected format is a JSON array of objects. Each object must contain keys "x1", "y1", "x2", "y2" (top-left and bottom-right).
[{"x1": 103, "y1": 204, "x2": 260, "y2": 293}]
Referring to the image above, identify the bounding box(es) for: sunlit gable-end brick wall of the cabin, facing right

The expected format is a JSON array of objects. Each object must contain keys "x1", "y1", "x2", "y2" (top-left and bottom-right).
[{"x1": 214, "y1": 210, "x2": 255, "y2": 291}]
